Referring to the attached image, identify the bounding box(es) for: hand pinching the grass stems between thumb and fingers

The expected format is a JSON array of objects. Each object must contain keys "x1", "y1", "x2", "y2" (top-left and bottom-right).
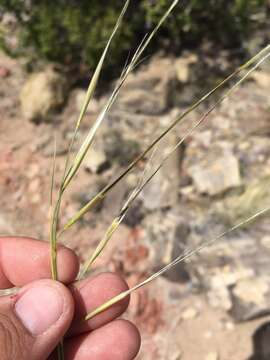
[{"x1": 0, "y1": 238, "x2": 140, "y2": 360}]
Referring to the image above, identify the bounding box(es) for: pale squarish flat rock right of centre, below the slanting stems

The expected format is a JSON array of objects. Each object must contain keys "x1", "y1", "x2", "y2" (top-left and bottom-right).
[{"x1": 188, "y1": 151, "x2": 241, "y2": 196}]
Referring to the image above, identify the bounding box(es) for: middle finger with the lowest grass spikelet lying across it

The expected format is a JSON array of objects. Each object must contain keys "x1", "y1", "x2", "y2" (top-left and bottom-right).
[{"x1": 68, "y1": 273, "x2": 129, "y2": 336}]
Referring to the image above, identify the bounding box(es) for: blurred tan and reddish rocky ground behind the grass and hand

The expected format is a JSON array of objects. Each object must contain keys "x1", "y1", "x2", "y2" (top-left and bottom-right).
[{"x1": 0, "y1": 25, "x2": 270, "y2": 360}]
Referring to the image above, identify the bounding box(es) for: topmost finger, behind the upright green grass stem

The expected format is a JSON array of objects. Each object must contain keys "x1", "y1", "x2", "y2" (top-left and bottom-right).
[{"x1": 0, "y1": 237, "x2": 79, "y2": 289}]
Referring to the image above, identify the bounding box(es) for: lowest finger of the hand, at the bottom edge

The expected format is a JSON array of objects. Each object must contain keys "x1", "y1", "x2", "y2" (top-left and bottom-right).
[{"x1": 65, "y1": 320, "x2": 141, "y2": 360}]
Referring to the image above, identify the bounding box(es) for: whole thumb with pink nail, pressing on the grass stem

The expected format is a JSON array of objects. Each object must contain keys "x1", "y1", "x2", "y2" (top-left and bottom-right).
[{"x1": 0, "y1": 280, "x2": 74, "y2": 360}]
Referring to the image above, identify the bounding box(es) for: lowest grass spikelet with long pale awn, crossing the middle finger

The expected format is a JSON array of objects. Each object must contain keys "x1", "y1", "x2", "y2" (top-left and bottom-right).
[{"x1": 85, "y1": 207, "x2": 270, "y2": 320}]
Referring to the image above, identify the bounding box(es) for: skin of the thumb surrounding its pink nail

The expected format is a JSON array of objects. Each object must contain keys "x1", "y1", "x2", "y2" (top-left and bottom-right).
[{"x1": 0, "y1": 280, "x2": 74, "y2": 360}]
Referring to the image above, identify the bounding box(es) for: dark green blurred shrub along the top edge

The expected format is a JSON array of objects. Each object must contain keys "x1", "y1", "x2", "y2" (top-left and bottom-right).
[{"x1": 0, "y1": 0, "x2": 267, "y2": 75}]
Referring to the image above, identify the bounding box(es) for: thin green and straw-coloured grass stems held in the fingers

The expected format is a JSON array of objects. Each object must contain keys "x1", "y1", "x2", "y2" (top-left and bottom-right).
[{"x1": 47, "y1": 0, "x2": 270, "y2": 360}]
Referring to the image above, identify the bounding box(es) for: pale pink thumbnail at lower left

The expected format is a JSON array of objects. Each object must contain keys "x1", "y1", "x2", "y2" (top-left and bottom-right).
[{"x1": 15, "y1": 286, "x2": 64, "y2": 336}]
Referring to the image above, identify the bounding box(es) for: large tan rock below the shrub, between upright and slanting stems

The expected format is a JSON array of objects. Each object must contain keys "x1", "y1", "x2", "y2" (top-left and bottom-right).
[{"x1": 117, "y1": 57, "x2": 176, "y2": 115}]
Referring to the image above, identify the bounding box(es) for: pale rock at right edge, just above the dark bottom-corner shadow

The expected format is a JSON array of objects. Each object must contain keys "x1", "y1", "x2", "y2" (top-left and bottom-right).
[{"x1": 229, "y1": 277, "x2": 270, "y2": 321}]
